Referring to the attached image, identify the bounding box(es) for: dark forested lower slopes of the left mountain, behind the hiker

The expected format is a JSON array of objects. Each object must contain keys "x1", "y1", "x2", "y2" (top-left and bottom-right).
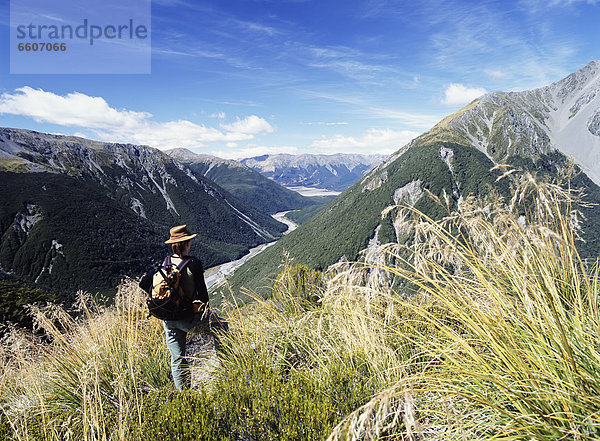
[{"x1": 0, "y1": 168, "x2": 285, "y2": 292}]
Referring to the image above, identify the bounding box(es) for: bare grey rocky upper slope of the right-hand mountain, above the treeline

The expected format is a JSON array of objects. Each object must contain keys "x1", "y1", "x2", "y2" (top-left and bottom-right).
[{"x1": 409, "y1": 61, "x2": 600, "y2": 185}]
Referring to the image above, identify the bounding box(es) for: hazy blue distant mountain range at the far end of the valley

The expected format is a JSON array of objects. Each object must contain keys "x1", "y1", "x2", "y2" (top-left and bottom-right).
[{"x1": 241, "y1": 153, "x2": 385, "y2": 191}]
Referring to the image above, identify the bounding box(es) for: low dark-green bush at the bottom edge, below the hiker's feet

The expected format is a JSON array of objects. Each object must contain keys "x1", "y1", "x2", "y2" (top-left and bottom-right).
[{"x1": 142, "y1": 360, "x2": 374, "y2": 441}]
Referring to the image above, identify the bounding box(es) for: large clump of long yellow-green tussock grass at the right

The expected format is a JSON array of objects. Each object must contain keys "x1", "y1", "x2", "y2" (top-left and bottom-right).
[{"x1": 331, "y1": 170, "x2": 600, "y2": 440}]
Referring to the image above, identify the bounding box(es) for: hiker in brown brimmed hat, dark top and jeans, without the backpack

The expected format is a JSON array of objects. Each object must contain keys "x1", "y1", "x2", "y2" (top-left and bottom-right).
[{"x1": 163, "y1": 225, "x2": 227, "y2": 390}]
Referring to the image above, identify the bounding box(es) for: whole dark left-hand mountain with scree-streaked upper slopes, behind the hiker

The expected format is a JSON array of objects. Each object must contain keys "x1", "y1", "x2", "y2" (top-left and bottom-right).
[{"x1": 0, "y1": 128, "x2": 286, "y2": 291}]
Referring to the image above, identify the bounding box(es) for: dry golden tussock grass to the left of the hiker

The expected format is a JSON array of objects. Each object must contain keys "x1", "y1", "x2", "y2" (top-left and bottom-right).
[{"x1": 0, "y1": 280, "x2": 170, "y2": 440}]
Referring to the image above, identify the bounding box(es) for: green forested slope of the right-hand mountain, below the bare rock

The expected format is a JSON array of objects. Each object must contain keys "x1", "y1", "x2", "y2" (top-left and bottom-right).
[{"x1": 219, "y1": 142, "x2": 600, "y2": 295}]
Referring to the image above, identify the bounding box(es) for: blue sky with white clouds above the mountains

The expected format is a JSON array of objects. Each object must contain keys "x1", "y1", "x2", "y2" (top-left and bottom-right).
[{"x1": 0, "y1": 0, "x2": 600, "y2": 159}]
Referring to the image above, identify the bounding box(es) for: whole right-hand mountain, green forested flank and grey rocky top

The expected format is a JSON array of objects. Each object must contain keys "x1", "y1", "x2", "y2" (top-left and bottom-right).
[{"x1": 224, "y1": 61, "x2": 600, "y2": 296}]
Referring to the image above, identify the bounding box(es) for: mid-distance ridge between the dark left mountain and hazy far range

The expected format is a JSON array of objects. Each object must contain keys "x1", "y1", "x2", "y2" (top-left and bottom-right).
[{"x1": 165, "y1": 149, "x2": 316, "y2": 214}]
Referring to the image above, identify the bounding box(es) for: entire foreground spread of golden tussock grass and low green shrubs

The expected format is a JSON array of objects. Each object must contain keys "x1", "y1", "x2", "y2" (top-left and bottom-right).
[{"x1": 0, "y1": 168, "x2": 600, "y2": 441}]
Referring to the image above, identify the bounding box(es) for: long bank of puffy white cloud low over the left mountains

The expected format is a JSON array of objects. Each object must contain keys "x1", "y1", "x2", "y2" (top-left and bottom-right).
[{"x1": 0, "y1": 87, "x2": 274, "y2": 149}]
